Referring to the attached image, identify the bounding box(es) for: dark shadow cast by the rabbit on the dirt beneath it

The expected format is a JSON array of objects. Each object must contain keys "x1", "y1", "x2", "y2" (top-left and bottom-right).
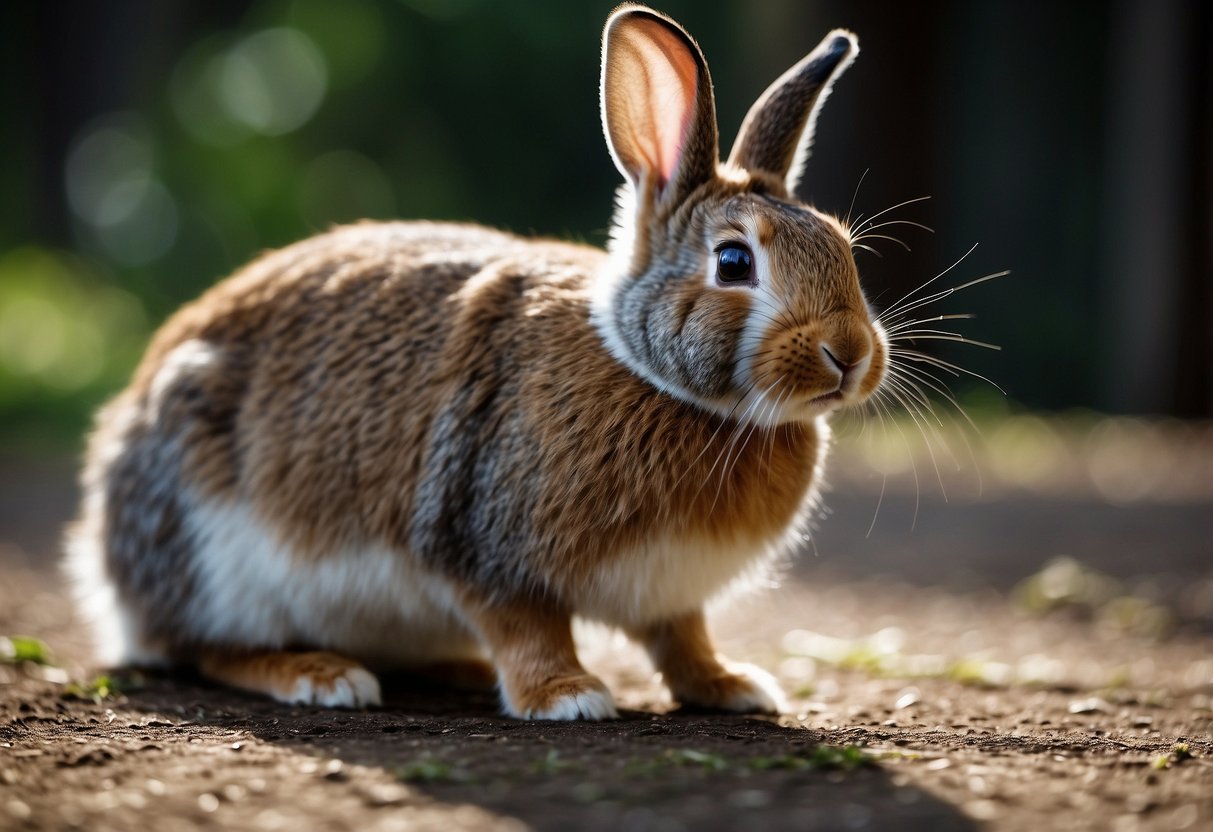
[{"x1": 101, "y1": 676, "x2": 976, "y2": 831}]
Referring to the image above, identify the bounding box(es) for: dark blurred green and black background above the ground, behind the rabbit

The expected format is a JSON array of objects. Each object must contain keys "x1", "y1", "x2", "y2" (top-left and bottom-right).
[{"x1": 0, "y1": 0, "x2": 1213, "y2": 449}]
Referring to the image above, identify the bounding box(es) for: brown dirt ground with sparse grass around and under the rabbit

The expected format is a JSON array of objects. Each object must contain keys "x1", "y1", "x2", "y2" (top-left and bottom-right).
[{"x1": 0, "y1": 422, "x2": 1213, "y2": 832}]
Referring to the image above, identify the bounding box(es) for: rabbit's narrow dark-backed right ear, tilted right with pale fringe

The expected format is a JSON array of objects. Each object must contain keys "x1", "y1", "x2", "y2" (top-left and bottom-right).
[{"x1": 729, "y1": 29, "x2": 859, "y2": 193}]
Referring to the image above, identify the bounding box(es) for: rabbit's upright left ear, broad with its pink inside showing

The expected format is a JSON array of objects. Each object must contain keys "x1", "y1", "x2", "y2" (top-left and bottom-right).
[{"x1": 602, "y1": 6, "x2": 719, "y2": 206}]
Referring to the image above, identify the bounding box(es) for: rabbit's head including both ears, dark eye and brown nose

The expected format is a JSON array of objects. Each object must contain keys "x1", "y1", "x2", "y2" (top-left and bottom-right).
[{"x1": 593, "y1": 6, "x2": 887, "y2": 424}]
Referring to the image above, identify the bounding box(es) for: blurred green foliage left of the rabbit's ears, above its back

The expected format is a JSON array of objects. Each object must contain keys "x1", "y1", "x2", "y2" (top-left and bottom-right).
[{"x1": 0, "y1": 0, "x2": 756, "y2": 448}]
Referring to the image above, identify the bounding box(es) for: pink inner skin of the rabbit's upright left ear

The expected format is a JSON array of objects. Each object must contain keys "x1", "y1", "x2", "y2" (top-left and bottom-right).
[{"x1": 636, "y1": 19, "x2": 699, "y2": 184}]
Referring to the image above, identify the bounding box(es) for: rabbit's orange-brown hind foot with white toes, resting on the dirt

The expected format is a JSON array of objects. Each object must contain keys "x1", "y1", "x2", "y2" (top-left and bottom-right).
[{"x1": 198, "y1": 649, "x2": 381, "y2": 708}]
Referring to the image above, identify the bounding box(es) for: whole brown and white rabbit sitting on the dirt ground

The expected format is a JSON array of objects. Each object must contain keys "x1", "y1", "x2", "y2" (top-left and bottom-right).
[{"x1": 68, "y1": 5, "x2": 888, "y2": 719}]
